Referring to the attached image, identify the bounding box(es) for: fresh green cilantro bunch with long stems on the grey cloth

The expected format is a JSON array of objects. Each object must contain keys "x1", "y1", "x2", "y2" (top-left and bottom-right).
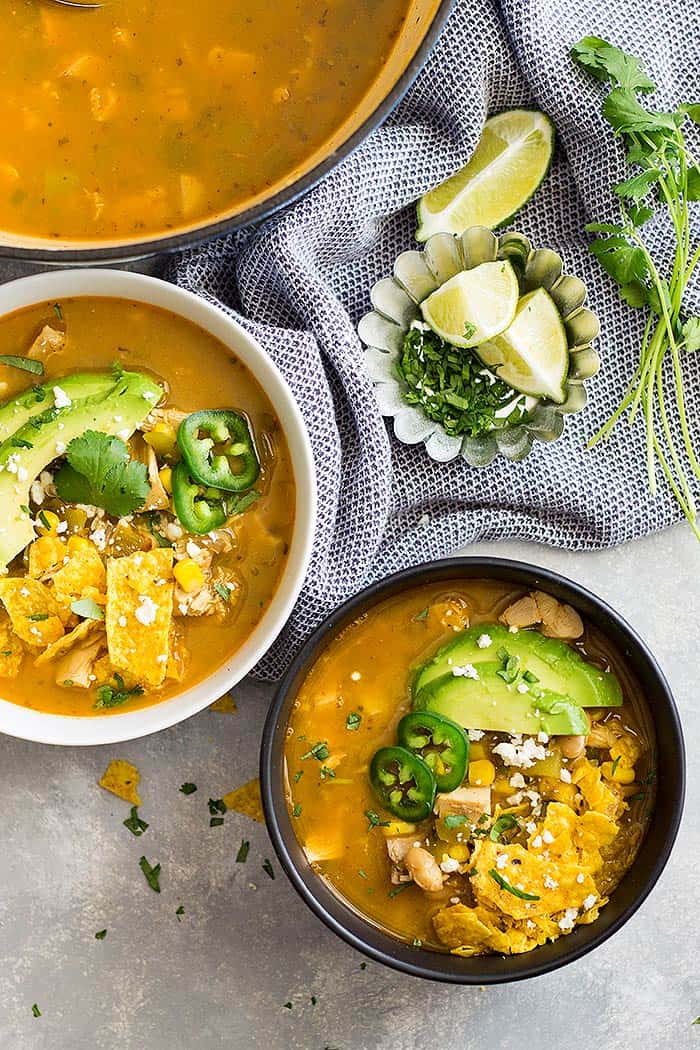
[{"x1": 571, "y1": 37, "x2": 700, "y2": 540}]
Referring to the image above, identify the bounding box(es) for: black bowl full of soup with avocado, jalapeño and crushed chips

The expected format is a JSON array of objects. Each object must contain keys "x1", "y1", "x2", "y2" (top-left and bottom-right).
[{"x1": 260, "y1": 558, "x2": 684, "y2": 985}]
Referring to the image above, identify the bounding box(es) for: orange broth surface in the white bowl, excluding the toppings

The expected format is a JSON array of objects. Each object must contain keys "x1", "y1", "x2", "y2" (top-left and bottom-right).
[{"x1": 0, "y1": 297, "x2": 295, "y2": 715}]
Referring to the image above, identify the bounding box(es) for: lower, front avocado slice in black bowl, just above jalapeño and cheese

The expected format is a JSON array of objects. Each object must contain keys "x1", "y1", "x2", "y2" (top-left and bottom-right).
[{"x1": 413, "y1": 660, "x2": 591, "y2": 736}]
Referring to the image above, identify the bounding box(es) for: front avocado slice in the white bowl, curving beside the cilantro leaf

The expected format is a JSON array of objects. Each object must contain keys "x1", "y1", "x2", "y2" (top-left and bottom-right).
[{"x1": 0, "y1": 372, "x2": 163, "y2": 566}]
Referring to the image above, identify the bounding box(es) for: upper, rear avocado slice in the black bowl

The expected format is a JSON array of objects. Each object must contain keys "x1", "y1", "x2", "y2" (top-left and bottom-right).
[{"x1": 413, "y1": 624, "x2": 622, "y2": 709}]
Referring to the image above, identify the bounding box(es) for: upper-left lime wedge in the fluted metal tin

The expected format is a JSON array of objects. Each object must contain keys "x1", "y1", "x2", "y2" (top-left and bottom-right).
[{"x1": 421, "y1": 263, "x2": 518, "y2": 347}]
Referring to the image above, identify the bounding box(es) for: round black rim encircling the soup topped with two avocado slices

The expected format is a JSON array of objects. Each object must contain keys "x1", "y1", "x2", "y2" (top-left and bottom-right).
[{"x1": 260, "y1": 555, "x2": 686, "y2": 985}]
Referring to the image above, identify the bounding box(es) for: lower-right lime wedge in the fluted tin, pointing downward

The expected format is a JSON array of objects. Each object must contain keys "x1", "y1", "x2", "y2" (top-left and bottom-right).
[{"x1": 476, "y1": 288, "x2": 569, "y2": 404}]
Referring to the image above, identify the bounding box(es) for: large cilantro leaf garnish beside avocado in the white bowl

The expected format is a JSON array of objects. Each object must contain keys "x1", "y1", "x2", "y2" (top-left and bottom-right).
[{"x1": 55, "y1": 431, "x2": 150, "y2": 518}]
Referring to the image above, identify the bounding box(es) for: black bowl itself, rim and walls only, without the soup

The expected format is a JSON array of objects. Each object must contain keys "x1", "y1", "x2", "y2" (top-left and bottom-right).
[{"x1": 260, "y1": 558, "x2": 685, "y2": 985}]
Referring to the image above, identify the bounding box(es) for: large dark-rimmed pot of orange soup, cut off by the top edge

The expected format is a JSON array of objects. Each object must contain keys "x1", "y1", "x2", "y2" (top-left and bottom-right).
[{"x1": 0, "y1": 0, "x2": 449, "y2": 263}]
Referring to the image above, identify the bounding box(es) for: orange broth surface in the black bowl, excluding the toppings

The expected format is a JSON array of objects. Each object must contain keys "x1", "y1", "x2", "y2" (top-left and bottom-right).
[{"x1": 285, "y1": 580, "x2": 653, "y2": 950}]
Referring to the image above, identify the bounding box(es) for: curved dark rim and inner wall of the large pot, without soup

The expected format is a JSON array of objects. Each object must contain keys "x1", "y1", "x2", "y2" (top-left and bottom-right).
[{"x1": 0, "y1": 0, "x2": 452, "y2": 266}]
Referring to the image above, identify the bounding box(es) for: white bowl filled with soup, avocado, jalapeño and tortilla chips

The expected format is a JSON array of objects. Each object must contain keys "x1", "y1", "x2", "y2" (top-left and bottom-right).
[{"x1": 0, "y1": 270, "x2": 316, "y2": 744}]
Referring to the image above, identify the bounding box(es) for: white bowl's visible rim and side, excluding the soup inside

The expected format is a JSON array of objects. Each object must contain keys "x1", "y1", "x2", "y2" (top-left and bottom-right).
[{"x1": 0, "y1": 270, "x2": 316, "y2": 744}]
